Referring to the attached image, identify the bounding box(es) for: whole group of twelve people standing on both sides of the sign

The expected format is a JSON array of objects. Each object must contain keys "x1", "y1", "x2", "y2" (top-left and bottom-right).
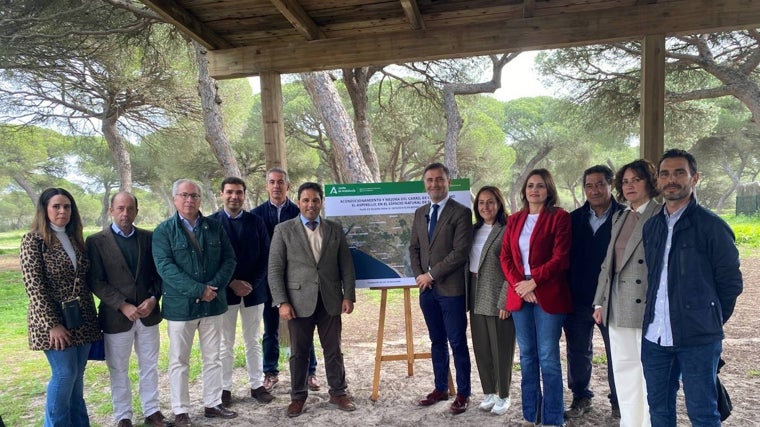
[{"x1": 20, "y1": 150, "x2": 742, "y2": 427}]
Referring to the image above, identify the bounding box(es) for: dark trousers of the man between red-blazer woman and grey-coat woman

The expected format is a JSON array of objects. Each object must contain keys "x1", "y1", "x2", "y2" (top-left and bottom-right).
[{"x1": 563, "y1": 306, "x2": 617, "y2": 404}]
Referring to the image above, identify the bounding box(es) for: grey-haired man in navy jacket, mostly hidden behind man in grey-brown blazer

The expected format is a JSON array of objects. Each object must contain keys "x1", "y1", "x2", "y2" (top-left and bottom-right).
[{"x1": 251, "y1": 167, "x2": 320, "y2": 391}]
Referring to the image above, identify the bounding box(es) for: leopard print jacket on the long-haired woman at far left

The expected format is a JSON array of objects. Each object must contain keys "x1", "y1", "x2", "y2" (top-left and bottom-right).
[{"x1": 20, "y1": 232, "x2": 101, "y2": 350}]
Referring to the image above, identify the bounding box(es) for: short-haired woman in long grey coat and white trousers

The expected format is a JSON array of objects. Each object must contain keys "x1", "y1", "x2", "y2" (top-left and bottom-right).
[{"x1": 594, "y1": 159, "x2": 662, "y2": 427}]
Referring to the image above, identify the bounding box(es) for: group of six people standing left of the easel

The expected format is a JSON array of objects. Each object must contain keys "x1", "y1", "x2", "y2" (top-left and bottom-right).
[{"x1": 20, "y1": 168, "x2": 355, "y2": 427}]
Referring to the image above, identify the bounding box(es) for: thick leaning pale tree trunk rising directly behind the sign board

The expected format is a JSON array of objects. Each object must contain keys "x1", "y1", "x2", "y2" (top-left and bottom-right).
[{"x1": 301, "y1": 71, "x2": 374, "y2": 183}]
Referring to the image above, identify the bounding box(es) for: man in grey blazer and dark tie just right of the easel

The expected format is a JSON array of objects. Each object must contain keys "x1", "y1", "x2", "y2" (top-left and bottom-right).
[{"x1": 409, "y1": 163, "x2": 472, "y2": 414}]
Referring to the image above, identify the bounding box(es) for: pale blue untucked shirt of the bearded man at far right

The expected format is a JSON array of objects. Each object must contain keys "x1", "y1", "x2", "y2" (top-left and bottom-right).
[{"x1": 644, "y1": 205, "x2": 688, "y2": 347}]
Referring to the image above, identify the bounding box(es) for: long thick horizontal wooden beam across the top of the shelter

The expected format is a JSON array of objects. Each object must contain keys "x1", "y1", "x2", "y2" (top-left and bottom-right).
[{"x1": 209, "y1": 0, "x2": 760, "y2": 78}]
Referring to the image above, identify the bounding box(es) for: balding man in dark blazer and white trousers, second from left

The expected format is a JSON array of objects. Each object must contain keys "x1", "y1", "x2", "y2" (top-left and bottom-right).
[{"x1": 86, "y1": 192, "x2": 165, "y2": 427}]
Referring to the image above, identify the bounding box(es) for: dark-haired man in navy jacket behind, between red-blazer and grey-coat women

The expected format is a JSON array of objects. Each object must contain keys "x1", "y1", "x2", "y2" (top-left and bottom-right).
[{"x1": 563, "y1": 165, "x2": 622, "y2": 418}]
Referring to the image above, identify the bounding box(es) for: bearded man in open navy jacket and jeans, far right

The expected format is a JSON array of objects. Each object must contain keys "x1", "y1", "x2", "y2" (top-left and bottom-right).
[{"x1": 641, "y1": 150, "x2": 743, "y2": 426}]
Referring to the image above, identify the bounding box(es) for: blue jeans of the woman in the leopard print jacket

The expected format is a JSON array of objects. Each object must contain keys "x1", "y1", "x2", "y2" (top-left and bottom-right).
[{"x1": 44, "y1": 343, "x2": 90, "y2": 427}]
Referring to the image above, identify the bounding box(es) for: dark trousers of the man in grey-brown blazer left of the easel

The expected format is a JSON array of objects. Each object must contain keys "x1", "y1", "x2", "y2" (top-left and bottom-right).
[{"x1": 288, "y1": 296, "x2": 346, "y2": 400}]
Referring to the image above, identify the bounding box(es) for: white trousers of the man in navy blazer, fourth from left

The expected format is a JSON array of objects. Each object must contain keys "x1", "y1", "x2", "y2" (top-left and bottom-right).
[{"x1": 220, "y1": 303, "x2": 264, "y2": 390}]
